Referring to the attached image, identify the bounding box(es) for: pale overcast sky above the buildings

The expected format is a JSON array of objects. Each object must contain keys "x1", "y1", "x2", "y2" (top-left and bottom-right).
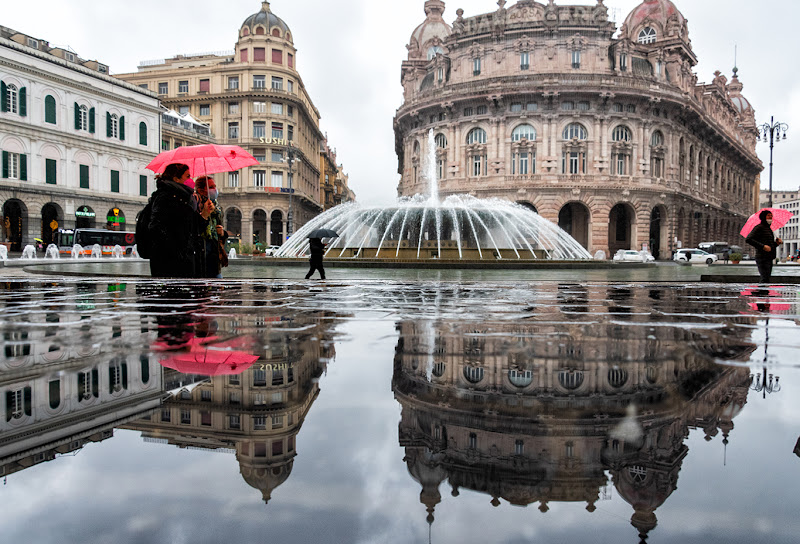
[{"x1": 0, "y1": 0, "x2": 800, "y2": 203}]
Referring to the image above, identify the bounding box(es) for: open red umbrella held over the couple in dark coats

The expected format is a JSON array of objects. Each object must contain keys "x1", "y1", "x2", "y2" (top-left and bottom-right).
[{"x1": 146, "y1": 144, "x2": 258, "y2": 178}]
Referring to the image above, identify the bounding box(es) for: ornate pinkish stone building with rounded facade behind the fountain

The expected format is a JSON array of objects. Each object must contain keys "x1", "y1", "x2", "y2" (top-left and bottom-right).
[{"x1": 394, "y1": 0, "x2": 762, "y2": 258}]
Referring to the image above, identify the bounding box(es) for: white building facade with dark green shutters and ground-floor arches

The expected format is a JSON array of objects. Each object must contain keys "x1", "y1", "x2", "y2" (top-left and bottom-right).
[{"x1": 0, "y1": 27, "x2": 161, "y2": 251}]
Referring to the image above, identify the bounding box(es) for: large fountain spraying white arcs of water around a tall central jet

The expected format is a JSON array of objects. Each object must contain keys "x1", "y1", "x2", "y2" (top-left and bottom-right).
[{"x1": 276, "y1": 130, "x2": 592, "y2": 260}]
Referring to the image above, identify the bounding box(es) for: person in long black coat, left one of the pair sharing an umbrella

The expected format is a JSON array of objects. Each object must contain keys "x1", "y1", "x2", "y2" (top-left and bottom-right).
[{"x1": 148, "y1": 164, "x2": 211, "y2": 278}]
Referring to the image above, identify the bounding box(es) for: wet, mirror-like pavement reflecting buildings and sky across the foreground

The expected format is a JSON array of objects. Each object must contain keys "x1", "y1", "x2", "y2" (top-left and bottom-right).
[{"x1": 0, "y1": 276, "x2": 800, "y2": 544}]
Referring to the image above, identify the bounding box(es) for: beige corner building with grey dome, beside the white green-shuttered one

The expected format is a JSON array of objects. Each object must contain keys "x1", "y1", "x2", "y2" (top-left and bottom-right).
[{"x1": 117, "y1": 2, "x2": 324, "y2": 245}]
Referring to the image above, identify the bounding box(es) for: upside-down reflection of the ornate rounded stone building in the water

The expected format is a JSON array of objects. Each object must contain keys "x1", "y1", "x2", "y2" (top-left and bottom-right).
[{"x1": 393, "y1": 285, "x2": 755, "y2": 540}]
